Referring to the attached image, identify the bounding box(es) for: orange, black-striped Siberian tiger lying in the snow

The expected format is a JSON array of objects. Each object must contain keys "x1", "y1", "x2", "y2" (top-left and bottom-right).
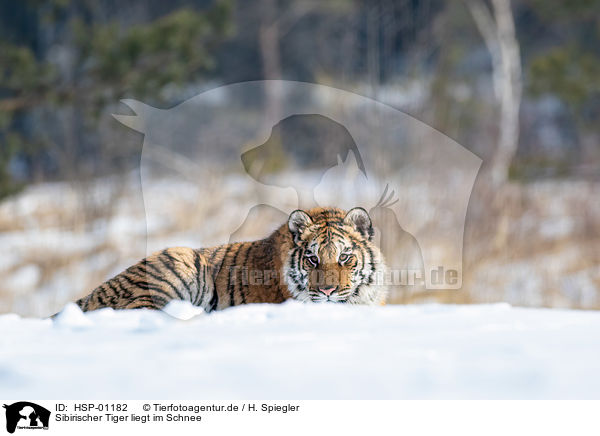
[{"x1": 76, "y1": 207, "x2": 387, "y2": 312}]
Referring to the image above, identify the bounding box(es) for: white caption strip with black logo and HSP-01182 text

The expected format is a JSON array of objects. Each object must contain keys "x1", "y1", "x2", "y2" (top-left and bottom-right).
[{"x1": 0, "y1": 399, "x2": 600, "y2": 436}]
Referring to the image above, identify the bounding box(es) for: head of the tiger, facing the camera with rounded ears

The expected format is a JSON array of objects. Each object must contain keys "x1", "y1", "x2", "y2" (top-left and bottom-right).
[{"x1": 284, "y1": 207, "x2": 387, "y2": 304}]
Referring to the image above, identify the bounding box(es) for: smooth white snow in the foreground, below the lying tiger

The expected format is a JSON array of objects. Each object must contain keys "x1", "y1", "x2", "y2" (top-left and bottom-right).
[{"x1": 0, "y1": 302, "x2": 600, "y2": 399}]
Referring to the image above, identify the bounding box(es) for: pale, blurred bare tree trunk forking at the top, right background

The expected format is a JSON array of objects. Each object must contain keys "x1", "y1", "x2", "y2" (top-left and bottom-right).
[{"x1": 466, "y1": 0, "x2": 522, "y2": 185}]
